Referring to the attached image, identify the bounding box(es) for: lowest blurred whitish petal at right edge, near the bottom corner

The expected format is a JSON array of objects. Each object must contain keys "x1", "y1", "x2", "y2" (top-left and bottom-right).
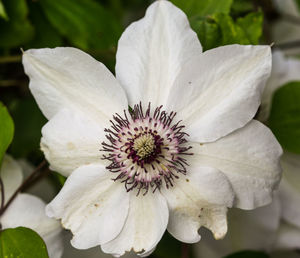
[{"x1": 274, "y1": 221, "x2": 300, "y2": 249}]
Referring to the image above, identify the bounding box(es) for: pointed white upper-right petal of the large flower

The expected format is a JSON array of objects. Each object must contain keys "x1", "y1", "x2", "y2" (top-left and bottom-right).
[{"x1": 167, "y1": 45, "x2": 271, "y2": 142}]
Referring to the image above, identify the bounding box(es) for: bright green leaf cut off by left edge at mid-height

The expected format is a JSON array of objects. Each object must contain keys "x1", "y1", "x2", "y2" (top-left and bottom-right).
[{"x1": 0, "y1": 102, "x2": 14, "y2": 164}]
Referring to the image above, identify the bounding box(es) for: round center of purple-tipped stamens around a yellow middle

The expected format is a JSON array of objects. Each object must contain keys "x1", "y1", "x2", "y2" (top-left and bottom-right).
[{"x1": 101, "y1": 103, "x2": 192, "y2": 195}]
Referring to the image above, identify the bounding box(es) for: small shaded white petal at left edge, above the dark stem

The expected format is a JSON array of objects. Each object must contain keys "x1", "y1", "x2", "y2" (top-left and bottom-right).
[{"x1": 0, "y1": 155, "x2": 23, "y2": 203}]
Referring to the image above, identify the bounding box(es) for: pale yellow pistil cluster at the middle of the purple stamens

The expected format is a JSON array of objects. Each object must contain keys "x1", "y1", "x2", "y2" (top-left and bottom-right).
[{"x1": 133, "y1": 134, "x2": 155, "y2": 159}]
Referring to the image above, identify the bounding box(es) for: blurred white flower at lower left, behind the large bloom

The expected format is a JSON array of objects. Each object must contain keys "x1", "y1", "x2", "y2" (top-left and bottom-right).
[{"x1": 0, "y1": 155, "x2": 63, "y2": 258}]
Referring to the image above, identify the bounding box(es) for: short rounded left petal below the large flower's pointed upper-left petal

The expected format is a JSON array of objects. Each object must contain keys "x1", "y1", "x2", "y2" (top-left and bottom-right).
[{"x1": 41, "y1": 109, "x2": 105, "y2": 176}]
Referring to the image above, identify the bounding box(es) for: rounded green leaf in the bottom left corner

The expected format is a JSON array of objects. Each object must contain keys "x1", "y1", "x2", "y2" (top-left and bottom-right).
[{"x1": 0, "y1": 227, "x2": 49, "y2": 258}]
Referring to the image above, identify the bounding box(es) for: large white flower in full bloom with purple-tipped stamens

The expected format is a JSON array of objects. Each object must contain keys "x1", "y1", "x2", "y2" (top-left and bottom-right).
[{"x1": 23, "y1": 1, "x2": 282, "y2": 256}]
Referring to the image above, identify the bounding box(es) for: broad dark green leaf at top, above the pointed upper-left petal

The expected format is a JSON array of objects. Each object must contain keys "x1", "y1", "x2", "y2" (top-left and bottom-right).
[{"x1": 39, "y1": 0, "x2": 122, "y2": 50}]
